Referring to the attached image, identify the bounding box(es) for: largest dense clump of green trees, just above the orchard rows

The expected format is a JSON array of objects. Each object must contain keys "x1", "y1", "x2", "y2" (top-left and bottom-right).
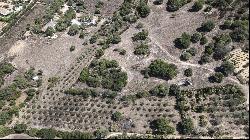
[{"x1": 79, "y1": 59, "x2": 127, "y2": 91}]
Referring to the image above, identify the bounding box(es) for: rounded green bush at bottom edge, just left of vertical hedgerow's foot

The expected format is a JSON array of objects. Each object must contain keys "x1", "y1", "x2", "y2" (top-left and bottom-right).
[{"x1": 151, "y1": 118, "x2": 175, "y2": 135}]
